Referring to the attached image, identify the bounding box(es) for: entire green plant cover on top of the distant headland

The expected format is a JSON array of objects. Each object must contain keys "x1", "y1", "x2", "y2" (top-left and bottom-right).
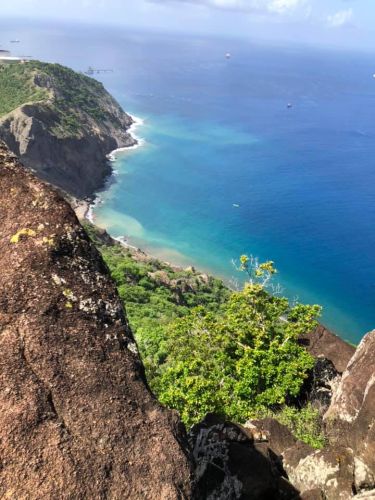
[{"x1": 0, "y1": 61, "x2": 121, "y2": 138}]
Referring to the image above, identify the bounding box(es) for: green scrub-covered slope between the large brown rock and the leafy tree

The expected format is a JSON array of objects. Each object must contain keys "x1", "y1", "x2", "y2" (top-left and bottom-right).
[{"x1": 85, "y1": 224, "x2": 230, "y2": 378}]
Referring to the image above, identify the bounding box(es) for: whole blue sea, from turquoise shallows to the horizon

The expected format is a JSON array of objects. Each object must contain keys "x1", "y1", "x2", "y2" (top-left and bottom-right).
[{"x1": 1, "y1": 18, "x2": 375, "y2": 342}]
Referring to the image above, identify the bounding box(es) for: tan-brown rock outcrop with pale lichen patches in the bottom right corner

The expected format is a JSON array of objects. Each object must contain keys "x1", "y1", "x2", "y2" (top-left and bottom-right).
[{"x1": 270, "y1": 331, "x2": 375, "y2": 500}]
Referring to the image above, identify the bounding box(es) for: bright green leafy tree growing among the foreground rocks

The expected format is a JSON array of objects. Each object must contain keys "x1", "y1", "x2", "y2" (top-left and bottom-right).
[{"x1": 156, "y1": 256, "x2": 320, "y2": 425}]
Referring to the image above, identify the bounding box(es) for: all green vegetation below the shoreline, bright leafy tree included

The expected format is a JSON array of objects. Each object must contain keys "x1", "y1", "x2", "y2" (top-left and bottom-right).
[{"x1": 86, "y1": 225, "x2": 323, "y2": 447}]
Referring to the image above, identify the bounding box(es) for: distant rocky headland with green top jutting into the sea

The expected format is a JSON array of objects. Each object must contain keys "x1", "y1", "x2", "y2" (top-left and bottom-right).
[{"x1": 0, "y1": 61, "x2": 136, "y2": 198}]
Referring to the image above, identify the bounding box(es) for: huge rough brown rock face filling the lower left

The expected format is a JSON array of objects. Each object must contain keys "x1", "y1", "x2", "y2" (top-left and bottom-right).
[{"x1": 0, "y1": 145, "x2": 190, "y2": 499}]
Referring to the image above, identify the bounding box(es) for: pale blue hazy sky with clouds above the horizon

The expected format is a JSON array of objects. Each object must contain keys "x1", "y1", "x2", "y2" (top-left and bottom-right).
[{"x1": 0, "y1": 0, "x2": 375, "y2": 50}]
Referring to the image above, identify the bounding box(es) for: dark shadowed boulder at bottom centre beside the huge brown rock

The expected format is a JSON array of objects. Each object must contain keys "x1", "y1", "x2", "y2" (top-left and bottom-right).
[{"x1": 189, "y1": 415, "x2": 299, "y2": 500}]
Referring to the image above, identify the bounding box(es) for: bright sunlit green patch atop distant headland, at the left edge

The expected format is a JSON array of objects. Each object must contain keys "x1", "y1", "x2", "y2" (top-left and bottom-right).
[{"x1": 0, "y1": 63, "x2": 49, "y2": 116}]
